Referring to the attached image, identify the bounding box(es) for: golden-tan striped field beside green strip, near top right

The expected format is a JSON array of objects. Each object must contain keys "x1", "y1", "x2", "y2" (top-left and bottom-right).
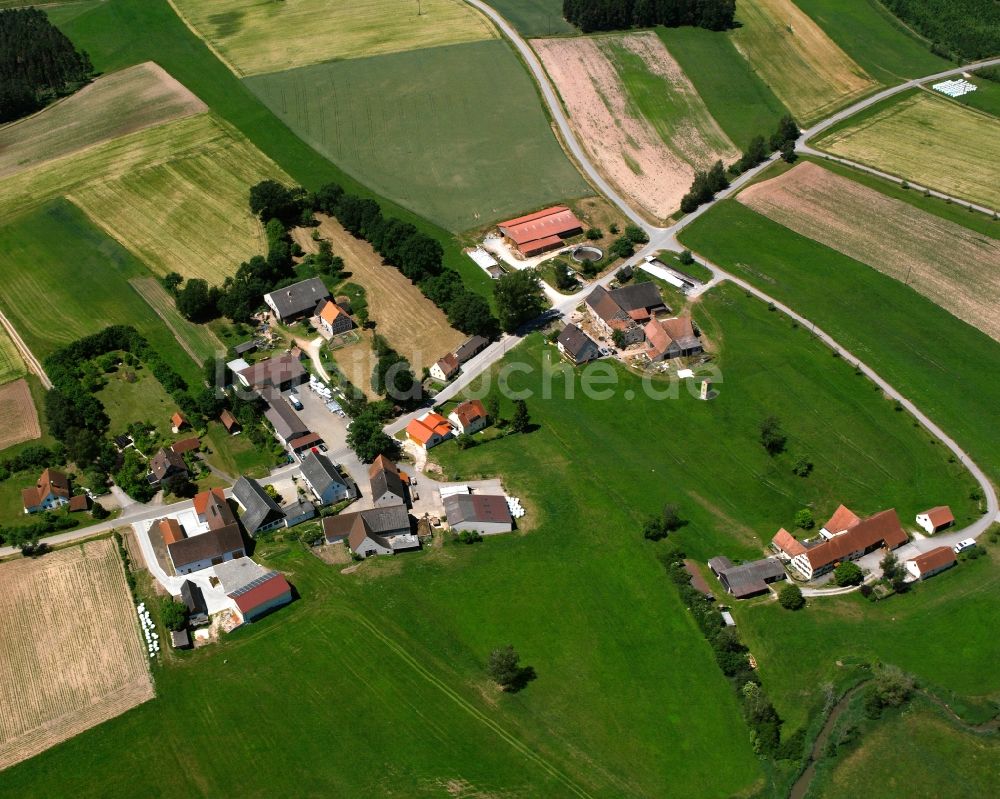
[{"x1": 731, "y1": 0, "x2": 879, "y2": 125}]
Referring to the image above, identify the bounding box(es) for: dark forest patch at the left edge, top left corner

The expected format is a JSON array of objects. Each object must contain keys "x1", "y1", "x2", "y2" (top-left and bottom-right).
[{"x1": 0, "y1": 8, "x2": 93, "y2": 122}]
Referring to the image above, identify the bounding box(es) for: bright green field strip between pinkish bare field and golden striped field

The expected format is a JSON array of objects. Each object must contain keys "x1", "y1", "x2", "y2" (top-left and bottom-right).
[{"x1": 656, "y1": 28, "x2": 786, "y2": 149}]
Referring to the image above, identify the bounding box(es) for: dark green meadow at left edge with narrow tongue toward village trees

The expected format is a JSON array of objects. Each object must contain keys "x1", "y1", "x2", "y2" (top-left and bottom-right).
[{"x1": 0, "y1": 200, "x2": 201, "y2": 381}]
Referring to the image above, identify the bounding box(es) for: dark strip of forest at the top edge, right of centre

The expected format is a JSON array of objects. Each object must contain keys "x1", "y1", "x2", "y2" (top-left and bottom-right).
[{"x1": 563, "y1": 0, "x2": 736, "y2": 33}]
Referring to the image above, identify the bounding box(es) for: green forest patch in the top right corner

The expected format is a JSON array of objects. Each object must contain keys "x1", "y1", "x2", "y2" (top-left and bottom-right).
[{"x1": 882, "y1": 0, "x2": 1000, "y2": 60}]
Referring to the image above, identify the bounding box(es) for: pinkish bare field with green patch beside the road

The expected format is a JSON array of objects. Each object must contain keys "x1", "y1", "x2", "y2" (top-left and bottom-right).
[{"x1": 532, "y1": 33, "x2": 739, "y2": 219}]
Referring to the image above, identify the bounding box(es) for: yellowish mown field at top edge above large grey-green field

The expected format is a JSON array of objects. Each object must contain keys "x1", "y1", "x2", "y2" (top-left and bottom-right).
[{"x1": 172, "y1": 0, "x2": 497, "y2": 76}]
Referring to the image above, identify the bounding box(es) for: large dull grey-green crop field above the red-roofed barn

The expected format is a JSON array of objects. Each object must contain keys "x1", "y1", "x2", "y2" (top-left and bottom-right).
[{"x1": 246, "y1": 41, "x2": 593, "y2": 233}]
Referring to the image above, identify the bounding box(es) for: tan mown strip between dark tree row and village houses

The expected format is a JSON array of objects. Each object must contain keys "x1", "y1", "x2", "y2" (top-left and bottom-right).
[{"x1": 294, "y1": 214, "x2": 465, "y2": 375}]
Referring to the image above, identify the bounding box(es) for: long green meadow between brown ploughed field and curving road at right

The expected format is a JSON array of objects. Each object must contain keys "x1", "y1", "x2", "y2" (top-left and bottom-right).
[{"x1": 681, "y1": 200, "x2": 1000, "y2": 488}]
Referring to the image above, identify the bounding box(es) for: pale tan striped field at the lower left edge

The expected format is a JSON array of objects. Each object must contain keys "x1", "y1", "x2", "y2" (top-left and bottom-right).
[{"x1": 0, "y1": 539, "x2": 153, "y2": 769}]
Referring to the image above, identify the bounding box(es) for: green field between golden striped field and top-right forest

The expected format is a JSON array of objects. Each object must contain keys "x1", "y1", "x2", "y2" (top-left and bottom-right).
[{"x1": 795, "y1": 0, "x2": 954, "y2": 85}]
